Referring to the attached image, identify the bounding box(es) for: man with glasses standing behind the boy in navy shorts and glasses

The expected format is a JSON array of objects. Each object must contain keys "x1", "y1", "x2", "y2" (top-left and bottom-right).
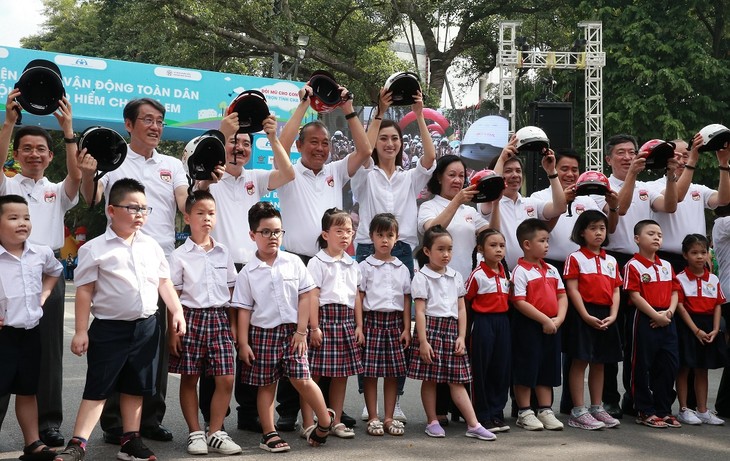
[{"x1": 79, "y1": 98, "x2": 188, "y2": 444}]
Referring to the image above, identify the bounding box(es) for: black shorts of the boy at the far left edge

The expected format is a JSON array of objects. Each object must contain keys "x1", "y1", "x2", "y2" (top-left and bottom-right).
[{"x1": 0, "y1": 326, "x2": 41, "y2": 395}]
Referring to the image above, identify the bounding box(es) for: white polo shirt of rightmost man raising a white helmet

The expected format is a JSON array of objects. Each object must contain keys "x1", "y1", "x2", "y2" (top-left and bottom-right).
[{"x1": 648, "y1": 176, "x2": 715, "y2": 254}]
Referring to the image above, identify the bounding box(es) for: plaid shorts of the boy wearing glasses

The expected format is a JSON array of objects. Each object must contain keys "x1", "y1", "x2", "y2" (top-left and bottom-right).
[{"x1": 241, "y1": 323, "x2": 309, "y2": 386}]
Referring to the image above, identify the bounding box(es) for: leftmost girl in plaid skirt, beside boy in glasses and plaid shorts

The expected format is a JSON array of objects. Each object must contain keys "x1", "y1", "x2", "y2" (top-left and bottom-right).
[{"x1": 302, "y1": 208, "x2": 364, "y2": 439}]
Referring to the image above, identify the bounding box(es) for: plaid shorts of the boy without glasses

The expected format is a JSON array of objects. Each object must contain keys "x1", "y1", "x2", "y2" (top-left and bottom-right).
[{"x1": 167, "y1": 307, "x2": 235, "y2": 376}]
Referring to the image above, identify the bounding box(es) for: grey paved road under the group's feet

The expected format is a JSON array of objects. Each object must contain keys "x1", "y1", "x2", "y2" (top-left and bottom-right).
[{"x1": 0, "y1": 285, "x2": 730, "y2": 461}]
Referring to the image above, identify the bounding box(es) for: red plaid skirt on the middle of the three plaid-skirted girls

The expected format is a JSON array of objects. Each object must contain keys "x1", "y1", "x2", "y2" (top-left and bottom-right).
[{"x1": 362, "y1": 311, "x2": 408, "y2": 378}]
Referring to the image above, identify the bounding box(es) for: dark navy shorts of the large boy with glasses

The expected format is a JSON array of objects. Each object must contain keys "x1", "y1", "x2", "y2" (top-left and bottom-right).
[{"x1": 84, "y1": 315, "x2": 160, "y2": 400}]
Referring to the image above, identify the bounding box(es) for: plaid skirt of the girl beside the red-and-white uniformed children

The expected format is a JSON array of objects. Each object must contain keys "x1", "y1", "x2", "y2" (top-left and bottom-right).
[{"x1": 408, "y1": 315, "x2": 471, "y2": 383}]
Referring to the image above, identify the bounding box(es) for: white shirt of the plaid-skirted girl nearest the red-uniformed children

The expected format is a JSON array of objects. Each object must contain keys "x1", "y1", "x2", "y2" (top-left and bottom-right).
[{"x1": 411, "y1": 266, "x2": 466, "y2": 319}]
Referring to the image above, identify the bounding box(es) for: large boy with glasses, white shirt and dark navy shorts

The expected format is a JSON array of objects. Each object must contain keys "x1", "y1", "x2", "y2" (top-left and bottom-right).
[{"x1": 56, "y1": 178, "x2": 185, "y2": 461}]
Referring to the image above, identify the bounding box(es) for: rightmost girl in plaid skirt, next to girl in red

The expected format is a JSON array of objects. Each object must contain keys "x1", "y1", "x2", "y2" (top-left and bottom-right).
[{"x1": 408, "y1": 225, "x2": 497, "y2": 440}]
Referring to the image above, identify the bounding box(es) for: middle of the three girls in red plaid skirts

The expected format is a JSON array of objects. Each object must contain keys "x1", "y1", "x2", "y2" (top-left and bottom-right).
[{"x1": 360, "y1": 213, "x2": 411, "y2": 435}]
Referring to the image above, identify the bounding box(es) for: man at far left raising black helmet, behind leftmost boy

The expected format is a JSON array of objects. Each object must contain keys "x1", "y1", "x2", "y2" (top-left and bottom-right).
[{"x1": 0, "y1": 89, "x2": 81, "y2": 447}]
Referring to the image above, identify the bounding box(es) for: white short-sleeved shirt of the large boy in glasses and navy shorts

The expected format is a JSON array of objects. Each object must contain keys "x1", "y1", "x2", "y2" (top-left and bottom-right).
[{"x1": 74, "y1": 227, "x2": 170, "y2": 320}]
